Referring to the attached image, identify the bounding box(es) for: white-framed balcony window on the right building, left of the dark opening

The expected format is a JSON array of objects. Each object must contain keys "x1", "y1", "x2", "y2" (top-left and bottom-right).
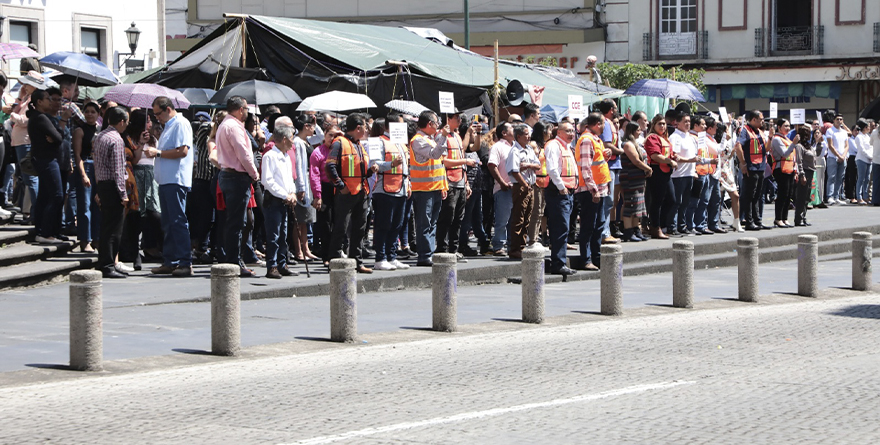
[{"x1": 658, "y1": 0, "x2": 697, "y2": 56}]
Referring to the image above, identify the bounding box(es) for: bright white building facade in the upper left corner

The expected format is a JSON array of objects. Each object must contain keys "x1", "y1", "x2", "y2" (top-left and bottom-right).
[{"x1": 0, "y1": 0, "x2": 165, "y2": 78}]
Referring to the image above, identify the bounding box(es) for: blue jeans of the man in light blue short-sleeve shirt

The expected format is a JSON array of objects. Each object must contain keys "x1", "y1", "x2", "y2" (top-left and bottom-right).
[{"x1": 159, "y1": 184, "x2": 192, "y2": 267}]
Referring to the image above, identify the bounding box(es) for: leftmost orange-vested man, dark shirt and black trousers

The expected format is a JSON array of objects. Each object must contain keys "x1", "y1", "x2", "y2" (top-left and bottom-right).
[{"x1": 325, "y1": 113, "x2": 378, "y2": 273}]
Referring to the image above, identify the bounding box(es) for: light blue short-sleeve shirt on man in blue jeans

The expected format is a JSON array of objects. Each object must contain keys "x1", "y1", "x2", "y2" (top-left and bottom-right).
[{"x1": 155, "y1": 114, "x2": 195, "y2": 187}]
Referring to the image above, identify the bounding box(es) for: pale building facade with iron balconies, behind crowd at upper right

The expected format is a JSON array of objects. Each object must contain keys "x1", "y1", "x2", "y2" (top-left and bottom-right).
[{"x1": 603, "y1": 0, "x2": 880, "y2": 122}]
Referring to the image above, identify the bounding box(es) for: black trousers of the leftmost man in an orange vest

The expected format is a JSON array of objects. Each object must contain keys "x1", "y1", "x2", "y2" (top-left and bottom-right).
[{"x1": 332, "y1": 190, "x2": 370, "y2": 266}]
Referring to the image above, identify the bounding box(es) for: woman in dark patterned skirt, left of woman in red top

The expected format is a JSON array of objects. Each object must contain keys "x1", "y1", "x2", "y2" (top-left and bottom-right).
[{"x1": 620, "y1": 122, "x2": 654, "y2": 242}]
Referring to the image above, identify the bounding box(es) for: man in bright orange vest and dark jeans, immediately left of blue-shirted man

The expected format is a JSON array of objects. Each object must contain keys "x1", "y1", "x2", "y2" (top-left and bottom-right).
[{"x1": 574, "y1": 113, "x2": 613, "y2": 270}]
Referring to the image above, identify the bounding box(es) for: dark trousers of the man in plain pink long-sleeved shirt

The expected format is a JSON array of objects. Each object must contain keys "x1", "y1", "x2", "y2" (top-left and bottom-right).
[{"x1": 218, "y1": 171, "x2": 253, "y2": 265}]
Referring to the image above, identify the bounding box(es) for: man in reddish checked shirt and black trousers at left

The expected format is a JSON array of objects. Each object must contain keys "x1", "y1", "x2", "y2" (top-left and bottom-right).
[{"x1": 92, "y1": 107, "x2": 128, "y2": 278}]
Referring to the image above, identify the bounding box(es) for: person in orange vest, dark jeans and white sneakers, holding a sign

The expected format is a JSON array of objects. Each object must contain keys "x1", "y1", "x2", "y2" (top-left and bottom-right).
[{"x1": 370, "y1": 114, "x2": 412, "y2": 270}]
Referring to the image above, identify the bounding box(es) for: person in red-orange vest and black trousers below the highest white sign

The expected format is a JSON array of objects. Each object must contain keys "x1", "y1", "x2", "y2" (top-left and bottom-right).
[{"x1": 437, "y1": 113, "x2": 477, "y2": 263}]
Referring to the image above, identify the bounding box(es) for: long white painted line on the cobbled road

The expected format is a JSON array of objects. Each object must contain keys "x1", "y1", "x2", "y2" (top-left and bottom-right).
[{"x1": 291, "y1": 381, "x2": 696, "y2": 445}]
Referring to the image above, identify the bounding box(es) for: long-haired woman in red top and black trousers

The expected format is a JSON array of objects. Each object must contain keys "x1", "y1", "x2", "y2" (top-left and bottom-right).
[{"x1": 645, "y1": 114, "x2": 678, "y2": 239}]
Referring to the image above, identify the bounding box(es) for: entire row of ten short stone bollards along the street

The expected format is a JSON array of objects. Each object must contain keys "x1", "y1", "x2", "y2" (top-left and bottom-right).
[{"x1": 70, "y1": 232, "x2": 873, "y2": 371}]
